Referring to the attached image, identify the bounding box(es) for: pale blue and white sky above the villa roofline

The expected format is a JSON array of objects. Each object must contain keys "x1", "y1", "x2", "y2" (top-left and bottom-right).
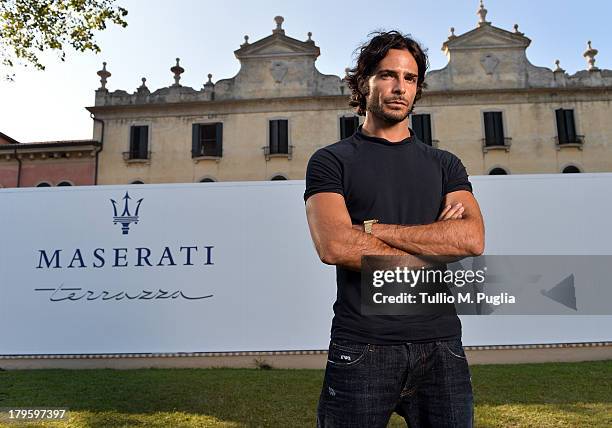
[{"x1": 0, "y1": 0, "x2": 612, "y2": 142}]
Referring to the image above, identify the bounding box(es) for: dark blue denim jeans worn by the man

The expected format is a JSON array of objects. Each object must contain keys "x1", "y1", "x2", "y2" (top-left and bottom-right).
[{"x1": 317, "y1": 338, "x2": 474, "y2": 428}]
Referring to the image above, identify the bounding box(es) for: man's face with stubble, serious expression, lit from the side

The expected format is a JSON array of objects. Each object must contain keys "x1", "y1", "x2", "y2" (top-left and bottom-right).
[{"x1": 366, "y1": 49, "x2": 419, "y2": 124}]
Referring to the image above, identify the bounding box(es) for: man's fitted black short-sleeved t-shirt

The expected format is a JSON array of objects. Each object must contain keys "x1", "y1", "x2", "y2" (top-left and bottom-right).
[{"x1": 304, "y1": 126, "x2": 472, "y2": 344}]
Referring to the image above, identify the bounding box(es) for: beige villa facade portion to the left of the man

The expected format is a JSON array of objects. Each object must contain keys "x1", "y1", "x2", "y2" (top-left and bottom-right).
[{"x1": 89, "y1": 17, "x2": 354, "y2": 184}]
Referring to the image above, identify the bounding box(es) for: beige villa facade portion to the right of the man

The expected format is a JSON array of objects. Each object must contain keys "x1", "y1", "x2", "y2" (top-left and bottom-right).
[{"x1": 416, "y1": 3, "x2": 612, "y2": 175}]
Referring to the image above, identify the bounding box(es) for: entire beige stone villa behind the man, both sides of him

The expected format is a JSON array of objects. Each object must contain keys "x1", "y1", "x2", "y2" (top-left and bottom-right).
[{"x1": 64, "y1": 3, "x2": 612, "y2": 184}]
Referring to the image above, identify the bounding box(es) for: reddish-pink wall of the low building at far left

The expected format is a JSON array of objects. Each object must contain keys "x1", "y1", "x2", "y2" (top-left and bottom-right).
[{"x1": 0, "y1": 157, "x2": 95, "y2": 187}]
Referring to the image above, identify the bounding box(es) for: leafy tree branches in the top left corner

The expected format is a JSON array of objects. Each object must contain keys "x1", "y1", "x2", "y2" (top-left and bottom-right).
[{"x1": 0, "y1": 0, "x2": 127, "y2": 79}]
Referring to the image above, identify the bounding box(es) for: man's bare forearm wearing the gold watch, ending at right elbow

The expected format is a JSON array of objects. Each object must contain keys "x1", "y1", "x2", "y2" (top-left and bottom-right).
[{"x1": 372, "y1": 219, "x2": 483, "y2": 261}]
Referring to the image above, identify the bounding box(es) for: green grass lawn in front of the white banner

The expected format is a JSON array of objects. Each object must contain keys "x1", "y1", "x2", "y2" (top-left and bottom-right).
[{"x1": 0, "y1": 361, "x2": 612, "y2": 428}]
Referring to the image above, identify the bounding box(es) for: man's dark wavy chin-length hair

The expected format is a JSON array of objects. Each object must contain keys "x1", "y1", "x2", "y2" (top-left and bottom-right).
[{"x1": 344, "y1": 30, "x2": 429, "y2": 116}]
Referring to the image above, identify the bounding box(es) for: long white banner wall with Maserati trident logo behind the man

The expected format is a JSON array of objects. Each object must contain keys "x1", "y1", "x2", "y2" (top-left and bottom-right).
[{"x1": 0, "y1": 173, "x2": 612, "y2": 355}]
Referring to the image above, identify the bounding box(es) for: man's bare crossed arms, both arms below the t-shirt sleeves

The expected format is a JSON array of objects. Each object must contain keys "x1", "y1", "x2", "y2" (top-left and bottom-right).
[{"x1": 306, "y1": 190, "x2": 484, "y2": 271}]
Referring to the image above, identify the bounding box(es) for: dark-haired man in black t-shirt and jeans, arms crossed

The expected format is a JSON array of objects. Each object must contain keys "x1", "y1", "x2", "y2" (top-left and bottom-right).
[{"x1": 304, "y1": 31, "x2": 484, "y2": 428}]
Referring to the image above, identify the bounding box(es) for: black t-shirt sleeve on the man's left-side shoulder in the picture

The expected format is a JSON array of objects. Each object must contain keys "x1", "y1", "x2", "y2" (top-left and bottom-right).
[{"x1": 304, "y1": 148, "x2": 344, "y2": 202}]
